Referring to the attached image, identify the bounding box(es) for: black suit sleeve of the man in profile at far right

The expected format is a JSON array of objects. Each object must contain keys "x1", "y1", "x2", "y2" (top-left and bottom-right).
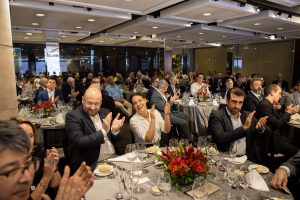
[{"x1": 258, "y1": 102, "x2": 290, "y2": 130}]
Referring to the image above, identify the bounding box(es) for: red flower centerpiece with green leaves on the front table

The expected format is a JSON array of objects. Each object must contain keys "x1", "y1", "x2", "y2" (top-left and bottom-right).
[{"x1": 156, "y1": 143, "x2": 209, "y2": 188}]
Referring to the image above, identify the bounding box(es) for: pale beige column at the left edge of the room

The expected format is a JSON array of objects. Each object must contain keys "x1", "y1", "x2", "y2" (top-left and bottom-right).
[{"x1": 0, "y1": 0, "x2": 18, "y2": 120}]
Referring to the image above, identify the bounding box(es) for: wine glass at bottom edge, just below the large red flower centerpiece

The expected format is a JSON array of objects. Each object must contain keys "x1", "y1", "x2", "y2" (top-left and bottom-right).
[{"x1": 192, "y1": 176, "x2": 208, "y2": 200}]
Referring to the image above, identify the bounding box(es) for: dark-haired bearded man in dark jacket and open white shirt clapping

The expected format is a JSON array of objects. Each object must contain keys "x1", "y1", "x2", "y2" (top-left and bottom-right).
[{"x1": 208, "y1": 87, "x2": 267, "y2": 162}]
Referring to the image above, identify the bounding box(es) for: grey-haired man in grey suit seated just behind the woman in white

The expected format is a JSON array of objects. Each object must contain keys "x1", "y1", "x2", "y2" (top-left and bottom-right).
[{"x1": 151, "y1": 80, "x2": 193, "y2": 143}]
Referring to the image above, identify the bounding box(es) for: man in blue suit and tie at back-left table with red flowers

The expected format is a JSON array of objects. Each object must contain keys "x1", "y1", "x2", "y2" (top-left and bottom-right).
[{"x1": 37, "y1": 78, "x2": 63, "y2": 103}]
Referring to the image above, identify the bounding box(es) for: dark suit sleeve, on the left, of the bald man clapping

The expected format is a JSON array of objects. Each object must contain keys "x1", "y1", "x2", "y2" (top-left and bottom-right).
[{"x1": 65, "y1": 112, "x2": 104, "y2": 150}]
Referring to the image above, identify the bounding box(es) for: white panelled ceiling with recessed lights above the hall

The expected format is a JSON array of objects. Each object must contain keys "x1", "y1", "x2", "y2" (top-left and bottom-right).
[{"x1": 10, "y1": 0, "x2": 300, "y2": 48}]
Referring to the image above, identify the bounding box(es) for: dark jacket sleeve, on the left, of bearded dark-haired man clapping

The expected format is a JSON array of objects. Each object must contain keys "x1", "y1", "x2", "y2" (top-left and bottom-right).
[{"x1": 208, "y1": 111, "x2": 247, "y2": 146}]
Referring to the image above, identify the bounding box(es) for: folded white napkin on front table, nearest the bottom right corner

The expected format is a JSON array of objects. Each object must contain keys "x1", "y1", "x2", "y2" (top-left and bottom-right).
[{"x1": 245, "y1": 170, "x2": 270, "y2": 192}]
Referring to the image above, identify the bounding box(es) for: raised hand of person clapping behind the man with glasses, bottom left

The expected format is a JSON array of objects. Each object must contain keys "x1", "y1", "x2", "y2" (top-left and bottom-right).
[{"x1": 43, "y1": 147, "x2": 59, "y2": 180}]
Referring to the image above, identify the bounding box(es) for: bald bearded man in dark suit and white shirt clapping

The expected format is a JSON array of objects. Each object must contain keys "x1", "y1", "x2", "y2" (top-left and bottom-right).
[{"x1": 65, "y1": 87, "x2": 125, "y2": 172}]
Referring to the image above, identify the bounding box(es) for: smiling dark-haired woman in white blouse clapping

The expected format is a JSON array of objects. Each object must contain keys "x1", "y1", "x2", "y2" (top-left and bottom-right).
[{"x1": 130, "y1": 93, "x2": 171, "y2": 145}]
